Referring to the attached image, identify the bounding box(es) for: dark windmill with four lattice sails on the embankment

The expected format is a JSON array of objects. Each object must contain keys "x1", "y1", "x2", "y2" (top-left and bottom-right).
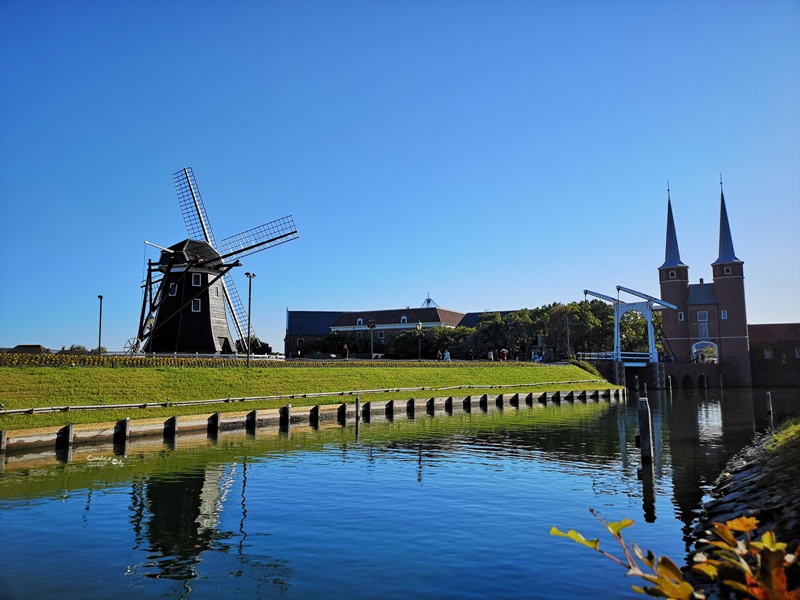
[{"x1": 131, "y1": 167, "x2": 299, "y2": 354}]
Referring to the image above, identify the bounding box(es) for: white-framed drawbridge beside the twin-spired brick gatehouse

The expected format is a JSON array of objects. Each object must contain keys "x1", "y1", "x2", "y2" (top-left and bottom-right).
[{"x1": 582, "y1": 285, "x2": 678, "y2": 367}]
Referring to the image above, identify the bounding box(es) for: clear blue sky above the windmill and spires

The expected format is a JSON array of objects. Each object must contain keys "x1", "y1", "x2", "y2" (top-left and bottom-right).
[{"x1": 0, "y1": 0, "x2": 800, "y2": 349}]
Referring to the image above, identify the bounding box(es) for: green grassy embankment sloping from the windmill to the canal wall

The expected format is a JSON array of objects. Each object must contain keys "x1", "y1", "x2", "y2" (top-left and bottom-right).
[{"x1": 0, "y1": 362, "x2": 615, "y2": 430}]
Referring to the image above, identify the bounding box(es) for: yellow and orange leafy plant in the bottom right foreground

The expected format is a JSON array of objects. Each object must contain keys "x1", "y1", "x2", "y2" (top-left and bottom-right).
[{"x1": 550, "y1": 509, "x2": 800, "y2": 600}]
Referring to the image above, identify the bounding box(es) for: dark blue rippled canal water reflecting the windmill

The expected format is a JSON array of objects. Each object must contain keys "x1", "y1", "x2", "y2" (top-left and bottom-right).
[{"x1": 0, "y1": 389, "x2": 800, "y2": 599}]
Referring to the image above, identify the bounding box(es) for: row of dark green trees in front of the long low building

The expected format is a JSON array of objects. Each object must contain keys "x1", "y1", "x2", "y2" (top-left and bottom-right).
[{"x1": 299, "y1": 300, "x2": 661, "y2": 360}]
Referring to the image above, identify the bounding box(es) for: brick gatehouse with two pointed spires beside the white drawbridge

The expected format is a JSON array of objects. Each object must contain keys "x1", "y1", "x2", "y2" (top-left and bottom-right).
[{"x1": 658, "y1": 181, "x2": 752, "y2": 386}]
